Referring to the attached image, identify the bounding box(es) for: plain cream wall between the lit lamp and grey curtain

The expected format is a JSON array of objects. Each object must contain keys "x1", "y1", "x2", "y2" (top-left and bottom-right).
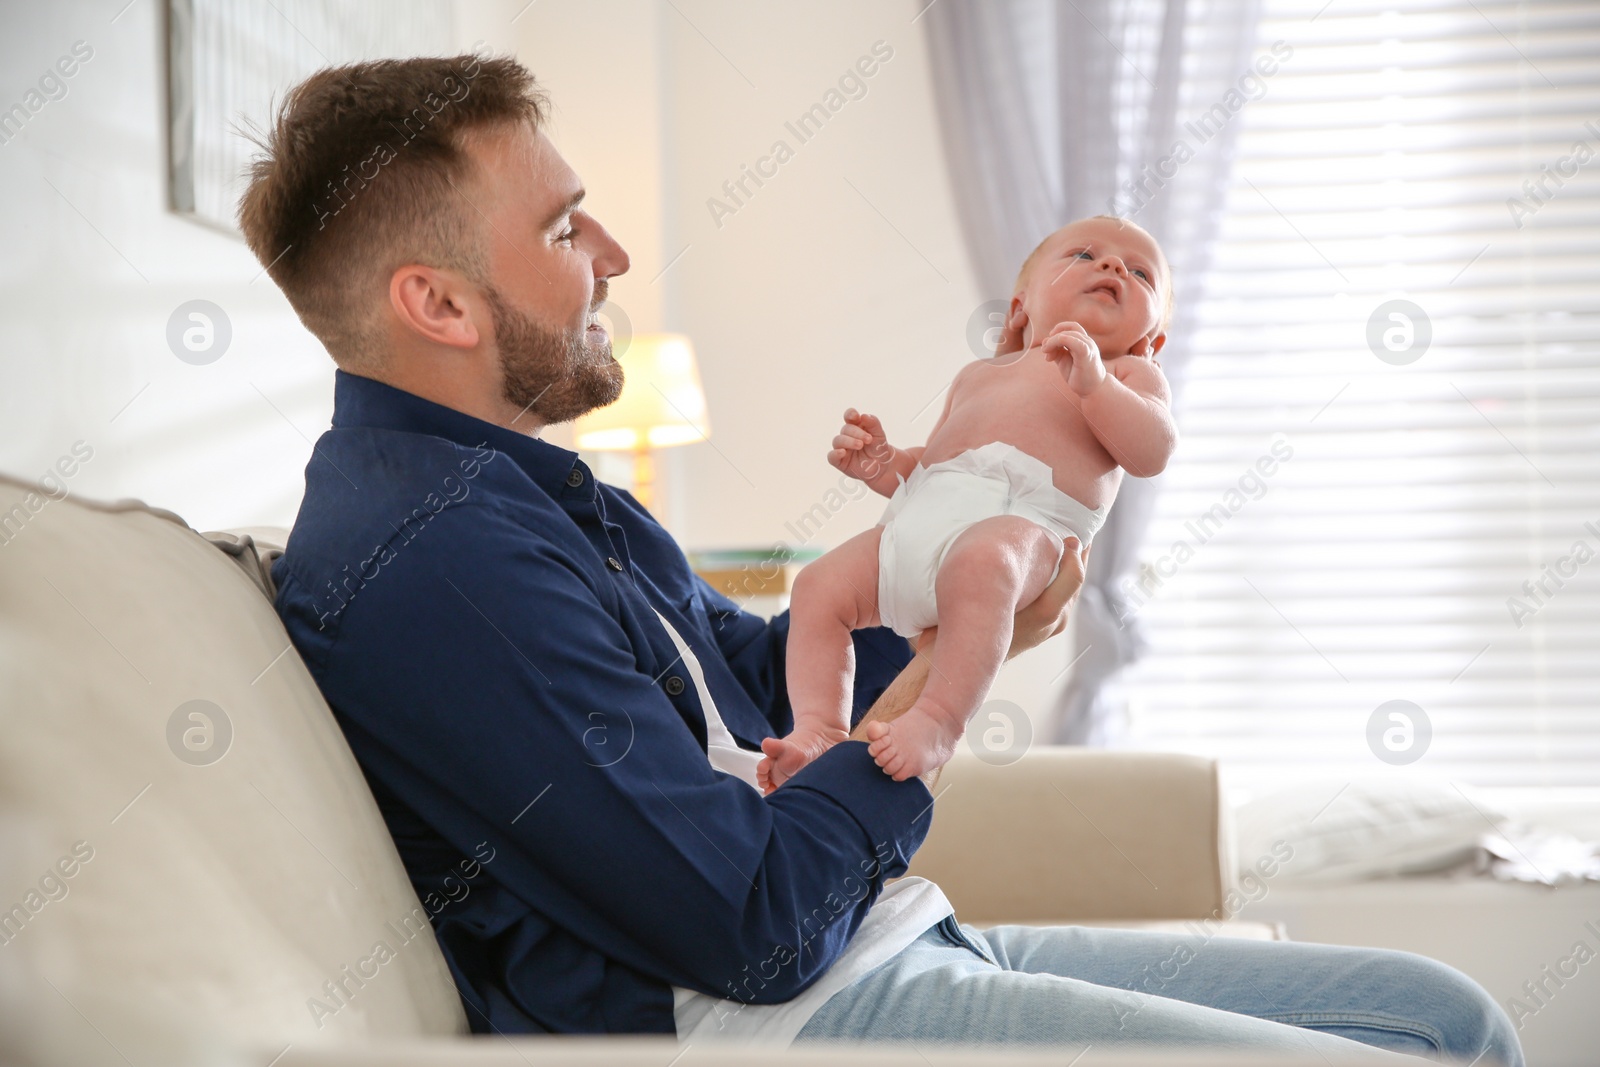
[{"x1": 666, "y1": 0, "x2": 979, "y2": 545}]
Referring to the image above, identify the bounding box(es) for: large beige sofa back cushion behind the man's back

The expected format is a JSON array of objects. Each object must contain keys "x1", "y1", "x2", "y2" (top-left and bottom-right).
[{"x1": 0, "y1": 478, "x2": 466, "y2": 1064}]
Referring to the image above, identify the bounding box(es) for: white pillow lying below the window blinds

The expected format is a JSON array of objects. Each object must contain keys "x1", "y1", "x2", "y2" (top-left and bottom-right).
[{"x1": 1235, "y1": 774, "x2": 1506, "y2": 881}]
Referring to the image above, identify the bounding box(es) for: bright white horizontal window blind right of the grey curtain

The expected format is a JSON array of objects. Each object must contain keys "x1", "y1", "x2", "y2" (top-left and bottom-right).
[{"x1": 1114, "y1": 0, "x2": 1600, "y2": 785}]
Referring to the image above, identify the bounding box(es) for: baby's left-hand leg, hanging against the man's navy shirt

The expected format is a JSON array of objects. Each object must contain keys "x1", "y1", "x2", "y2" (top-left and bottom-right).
[{"x1": 757, "y1": 526, "x2": 883, "y2": 792}]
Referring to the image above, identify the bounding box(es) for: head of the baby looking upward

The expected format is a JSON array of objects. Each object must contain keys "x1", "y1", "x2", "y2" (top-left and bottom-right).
[{"x1": 1000, "y1": 214, "x2": 1173, "y2": 358}]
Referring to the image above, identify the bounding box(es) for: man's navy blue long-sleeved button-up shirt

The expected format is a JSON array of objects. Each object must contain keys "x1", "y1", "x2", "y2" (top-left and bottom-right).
[{"x1": 272, "y1": 371, "x2": 931, "y2": 1033}]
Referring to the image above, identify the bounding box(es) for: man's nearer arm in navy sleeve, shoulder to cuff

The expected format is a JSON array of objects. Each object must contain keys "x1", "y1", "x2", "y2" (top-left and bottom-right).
[{"x1": 307, "y1": 506, "x2": 930, "y2": 1003}]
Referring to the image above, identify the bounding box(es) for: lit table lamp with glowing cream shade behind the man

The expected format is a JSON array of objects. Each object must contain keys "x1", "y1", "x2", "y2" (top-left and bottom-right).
[{"x1": 573, "y1": 333, "x2": 710, "y2": 507}]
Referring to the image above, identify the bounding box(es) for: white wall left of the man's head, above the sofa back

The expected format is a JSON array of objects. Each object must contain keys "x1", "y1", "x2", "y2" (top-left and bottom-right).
[{"x1": 0, "y1": 0, "x2": 515, "y2": 530}]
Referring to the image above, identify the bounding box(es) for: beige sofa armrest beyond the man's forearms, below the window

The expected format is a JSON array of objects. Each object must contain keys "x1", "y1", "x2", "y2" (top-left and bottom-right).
[{"x1": 907, "y1": 745, "x2": 1234, "y2": 925}]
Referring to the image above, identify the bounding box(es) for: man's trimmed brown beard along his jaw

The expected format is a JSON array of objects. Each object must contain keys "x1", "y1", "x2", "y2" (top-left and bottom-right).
[{"x1": 483, "y1": 280, "x2": 622, "y2": 426}]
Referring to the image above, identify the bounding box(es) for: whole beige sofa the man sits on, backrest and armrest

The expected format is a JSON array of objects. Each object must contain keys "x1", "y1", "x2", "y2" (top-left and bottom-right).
[{"x1": 0, "y1": 477, "x2": 1322, "y2": 1067}]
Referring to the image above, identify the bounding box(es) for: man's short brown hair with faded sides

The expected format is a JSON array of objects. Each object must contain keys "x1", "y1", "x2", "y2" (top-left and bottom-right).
[{"x1": 238, "y1": 54, "x2": 546, "y2": 370}]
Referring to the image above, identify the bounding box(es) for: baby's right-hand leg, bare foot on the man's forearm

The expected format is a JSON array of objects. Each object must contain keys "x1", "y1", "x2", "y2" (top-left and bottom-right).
[{"x1": 867, "y1": 515, "x2": 1061, "y2": 781}]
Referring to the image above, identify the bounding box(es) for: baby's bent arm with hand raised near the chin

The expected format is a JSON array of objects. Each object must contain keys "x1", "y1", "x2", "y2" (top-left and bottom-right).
[{"x1": 1045, "y1": 323, "x2": 1178, "y2": 478}]
